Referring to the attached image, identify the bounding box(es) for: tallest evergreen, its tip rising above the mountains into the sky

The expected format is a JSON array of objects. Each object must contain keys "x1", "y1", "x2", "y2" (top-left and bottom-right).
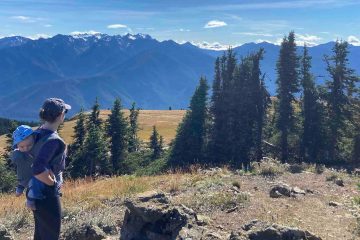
[{"x1": 276, "y1": 32, "x2": 299, "y2": 163}]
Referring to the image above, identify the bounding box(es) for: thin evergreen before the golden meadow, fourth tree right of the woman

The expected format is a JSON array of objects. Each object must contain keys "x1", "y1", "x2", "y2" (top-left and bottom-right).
[{"x1": 128, "y1": 103, "x2": 140, "y2": 152}]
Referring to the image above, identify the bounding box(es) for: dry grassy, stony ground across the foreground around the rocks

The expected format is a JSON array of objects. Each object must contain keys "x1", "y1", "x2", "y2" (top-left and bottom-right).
[{"x1": 0, "y1": 169, "x2": 360, "y2": 240}]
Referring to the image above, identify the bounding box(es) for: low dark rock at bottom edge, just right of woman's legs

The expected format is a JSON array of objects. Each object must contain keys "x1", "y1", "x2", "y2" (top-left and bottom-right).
[{"x1": 63, "y1": 224, "x2": 106, "y2": 240}]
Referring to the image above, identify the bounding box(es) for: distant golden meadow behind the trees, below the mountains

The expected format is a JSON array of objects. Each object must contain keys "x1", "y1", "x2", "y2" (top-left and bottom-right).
[{"x1": 0, "y1": 110, "x2": 185, "y2": 152}]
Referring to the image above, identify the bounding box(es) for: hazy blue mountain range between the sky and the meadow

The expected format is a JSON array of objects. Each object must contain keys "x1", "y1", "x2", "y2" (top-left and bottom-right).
[{"x1": 0, "y1": 34, "x2": 360, "y2": 120}]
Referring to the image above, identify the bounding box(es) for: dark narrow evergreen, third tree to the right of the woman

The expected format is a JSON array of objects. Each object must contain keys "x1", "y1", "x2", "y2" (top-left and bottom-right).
[{"x1": 107, "y1": 98, "x2": 128, "y2": 174}]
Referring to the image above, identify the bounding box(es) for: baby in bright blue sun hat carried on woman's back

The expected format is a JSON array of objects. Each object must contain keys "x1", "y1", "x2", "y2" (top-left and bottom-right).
[{"x1": 11, "y1": 125, "x2": 35, "y2": 210}]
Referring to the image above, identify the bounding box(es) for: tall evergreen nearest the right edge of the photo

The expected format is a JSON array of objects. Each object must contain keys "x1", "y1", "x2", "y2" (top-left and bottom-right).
[{"x1": 325, "y1": 41, "x2": 358, "y2": 162}]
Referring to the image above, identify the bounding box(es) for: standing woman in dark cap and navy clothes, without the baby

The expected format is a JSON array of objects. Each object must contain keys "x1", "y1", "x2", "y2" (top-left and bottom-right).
[{"x1": 30, "y1": 98, "x2": 71, "y2": 240}]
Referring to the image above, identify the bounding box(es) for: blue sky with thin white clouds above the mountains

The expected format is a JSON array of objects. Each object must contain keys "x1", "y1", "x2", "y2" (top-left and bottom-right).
[{"x1": 0, "y1": 0, "x2": 360, "y2": 46}]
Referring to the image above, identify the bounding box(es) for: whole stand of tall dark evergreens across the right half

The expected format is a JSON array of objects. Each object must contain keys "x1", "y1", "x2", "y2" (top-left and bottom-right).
[{"x1": 169, "y1": 32, "x2": 360, "y2": 170}]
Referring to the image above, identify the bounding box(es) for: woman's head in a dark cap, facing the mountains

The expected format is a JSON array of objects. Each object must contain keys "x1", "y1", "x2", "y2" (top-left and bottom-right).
[{"x1": 39, "y1": 98, "x2": 71, "y2": 123}]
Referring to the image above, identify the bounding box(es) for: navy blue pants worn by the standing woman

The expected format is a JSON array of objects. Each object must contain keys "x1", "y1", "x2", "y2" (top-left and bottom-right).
[{"x1": 33, "y1": 195, "x2": 61, "y2": 240}]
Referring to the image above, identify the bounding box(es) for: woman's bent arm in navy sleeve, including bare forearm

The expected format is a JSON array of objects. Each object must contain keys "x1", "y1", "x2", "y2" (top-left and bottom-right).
[{"x1": 33, "y1": 140, "x2": 60, "y2": 186}]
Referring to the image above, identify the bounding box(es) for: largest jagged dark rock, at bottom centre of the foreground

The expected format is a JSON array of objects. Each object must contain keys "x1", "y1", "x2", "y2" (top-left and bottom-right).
[{"x1": 120, "y1": 192, "x2": 225, "y2": 240}]
